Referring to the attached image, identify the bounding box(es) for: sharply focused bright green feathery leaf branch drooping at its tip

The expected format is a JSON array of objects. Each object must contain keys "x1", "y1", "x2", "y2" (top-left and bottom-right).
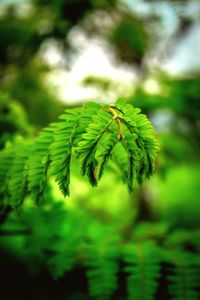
[{"x1": 0, "y1": 101, "x2": 159, "y2": 207}]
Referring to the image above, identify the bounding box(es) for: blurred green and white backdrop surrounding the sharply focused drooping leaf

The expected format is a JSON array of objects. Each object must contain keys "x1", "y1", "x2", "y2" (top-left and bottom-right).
[{"x1": 0, "y1": 0, "x2": 200, "y2": 300}]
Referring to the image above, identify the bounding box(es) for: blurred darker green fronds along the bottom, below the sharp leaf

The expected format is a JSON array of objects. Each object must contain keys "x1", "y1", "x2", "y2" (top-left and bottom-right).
[{"x1": 3, "y1": 202, "x2": 200, "y2": 300}]
